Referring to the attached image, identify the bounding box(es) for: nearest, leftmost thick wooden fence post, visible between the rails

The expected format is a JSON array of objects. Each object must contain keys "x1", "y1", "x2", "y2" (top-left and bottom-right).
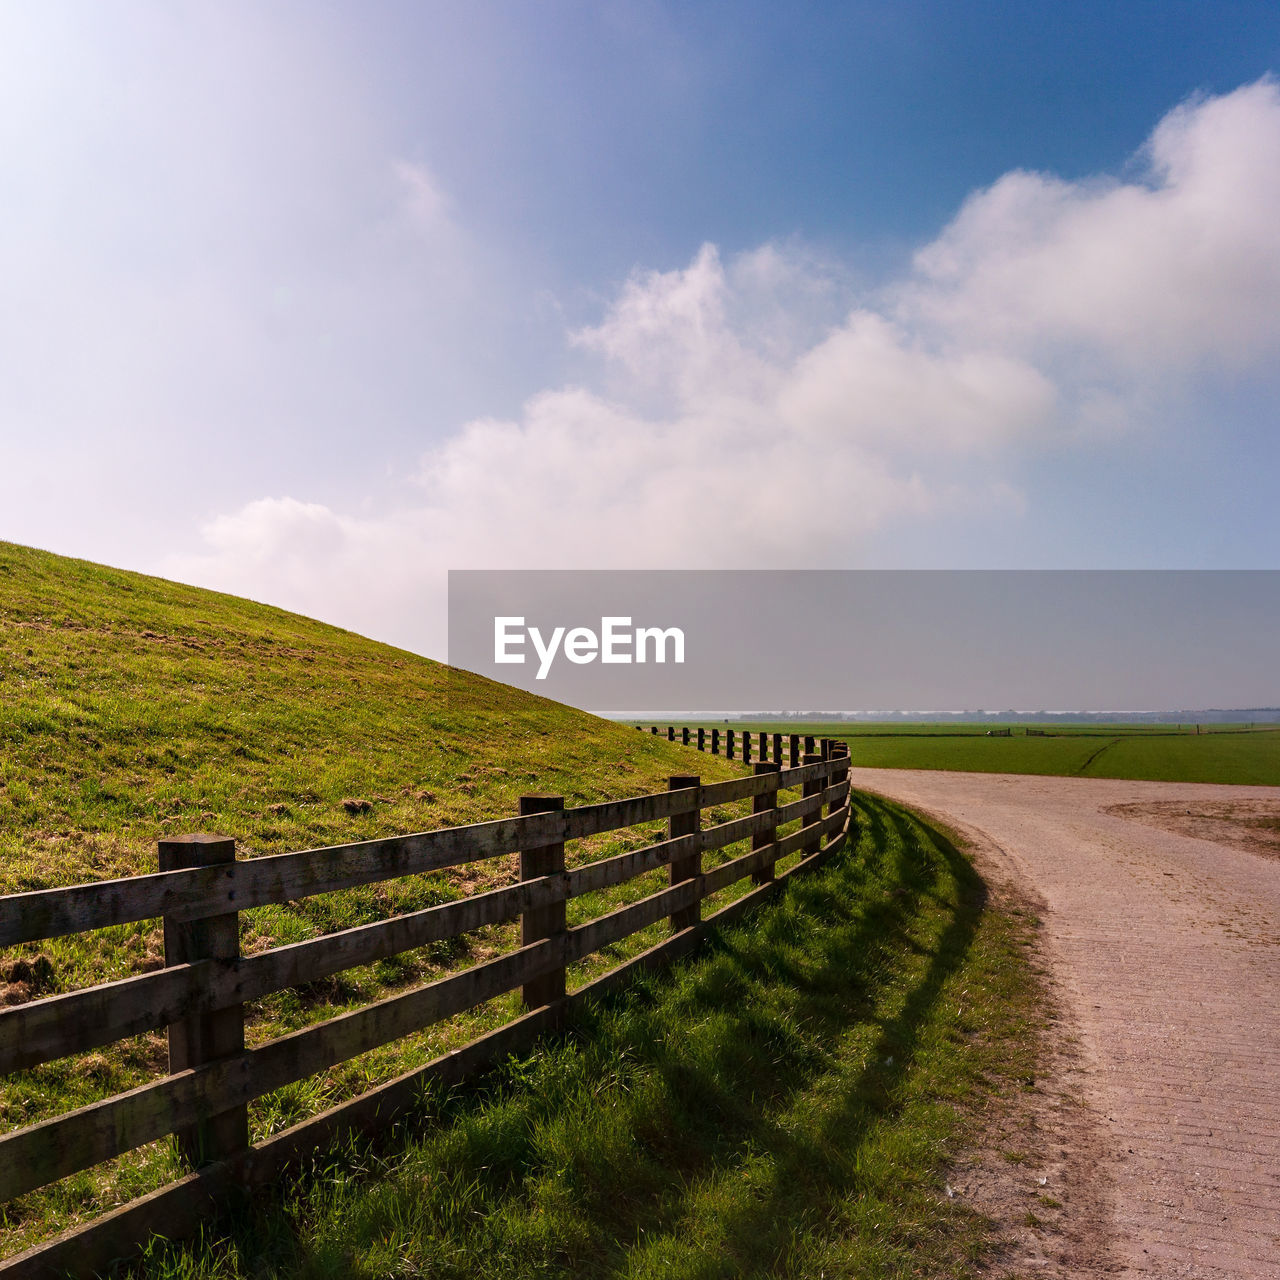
[{"x1": 159, "y1": 836, "x2": 248, "y2": 1167}]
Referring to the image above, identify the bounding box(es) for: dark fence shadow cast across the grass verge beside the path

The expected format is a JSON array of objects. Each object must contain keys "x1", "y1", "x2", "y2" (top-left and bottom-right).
[{"x1": 576, "y1": 799, "x2": 987, "y2": 1275}]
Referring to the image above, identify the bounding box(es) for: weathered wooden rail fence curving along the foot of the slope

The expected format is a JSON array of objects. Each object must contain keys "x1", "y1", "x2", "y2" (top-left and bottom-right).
[{"x1": 0, "y1": 742, "x2": 850, "y2": 1280}]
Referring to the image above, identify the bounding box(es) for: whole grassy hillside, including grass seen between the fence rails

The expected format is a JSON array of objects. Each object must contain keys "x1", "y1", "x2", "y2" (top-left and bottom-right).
[{"x1": 0, "y1": 543, "x2": 741, "y2": 1254}]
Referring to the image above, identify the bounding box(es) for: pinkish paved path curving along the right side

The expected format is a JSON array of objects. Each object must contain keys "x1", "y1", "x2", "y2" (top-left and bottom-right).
[{"x1": 854, "y1": 769, "x2": 1280, "y2": 1280}]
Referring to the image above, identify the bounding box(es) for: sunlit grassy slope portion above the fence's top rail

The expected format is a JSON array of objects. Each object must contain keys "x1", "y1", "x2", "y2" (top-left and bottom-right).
[{"x1": 0, "y1": 543, "x2": 737, "y2": 892}]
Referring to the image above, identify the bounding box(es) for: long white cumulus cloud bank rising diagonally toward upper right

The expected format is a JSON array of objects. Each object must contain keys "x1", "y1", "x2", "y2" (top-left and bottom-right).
[{"x1": 172, "y1": 78, "x2": 1280, "y2": 652}]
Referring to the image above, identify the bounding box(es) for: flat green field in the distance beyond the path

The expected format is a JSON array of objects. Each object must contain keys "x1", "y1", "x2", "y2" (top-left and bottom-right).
[{"x1": 655, "y1": 721, "x2": 1280, "y2": 786}]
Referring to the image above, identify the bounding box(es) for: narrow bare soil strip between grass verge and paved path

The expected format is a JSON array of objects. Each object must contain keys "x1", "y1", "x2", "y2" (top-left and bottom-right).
[{"x1": 947, "y1": 827, "x2": 1120, "y2": 1280}]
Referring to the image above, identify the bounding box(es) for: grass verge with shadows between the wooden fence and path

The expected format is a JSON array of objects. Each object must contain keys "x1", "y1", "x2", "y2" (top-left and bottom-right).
[{"x1": 127, "y1": 799, "x2": 1042, "y2": 1280}]
